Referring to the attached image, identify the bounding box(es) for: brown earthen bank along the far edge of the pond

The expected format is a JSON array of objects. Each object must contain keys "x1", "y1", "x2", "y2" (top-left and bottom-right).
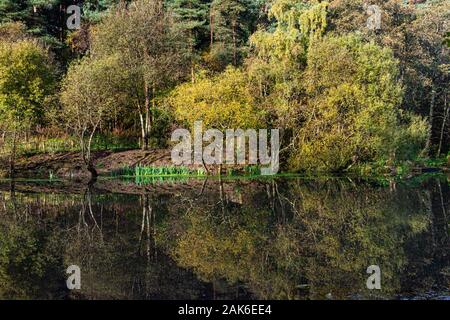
[{"x1": 0, "y1": 149, "x2": 450, "y2": 180}]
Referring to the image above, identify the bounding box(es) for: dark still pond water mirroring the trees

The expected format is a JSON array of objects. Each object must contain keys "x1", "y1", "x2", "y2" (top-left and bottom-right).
[{"x1": 0, "y1": 177, "x2": 450, "y2": 299}]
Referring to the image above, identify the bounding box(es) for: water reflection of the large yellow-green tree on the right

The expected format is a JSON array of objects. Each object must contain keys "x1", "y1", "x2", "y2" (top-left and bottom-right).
[{"x1": 293, "y1": 181, "x2": 427, "y2": 298}]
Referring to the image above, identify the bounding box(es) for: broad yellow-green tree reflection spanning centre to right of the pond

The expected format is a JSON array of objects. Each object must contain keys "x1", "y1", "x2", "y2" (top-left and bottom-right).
[{"x1": 167, "y1": 181, "x2": 442, "y2": 298}]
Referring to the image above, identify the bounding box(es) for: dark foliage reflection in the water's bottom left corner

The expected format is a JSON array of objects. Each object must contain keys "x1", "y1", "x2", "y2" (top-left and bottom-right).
[{"x1": 0, "y1": 195, "x2": 63, "y2": 299}]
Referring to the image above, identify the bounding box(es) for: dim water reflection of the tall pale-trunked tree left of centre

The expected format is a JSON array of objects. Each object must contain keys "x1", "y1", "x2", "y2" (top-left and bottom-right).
[{"x1": 65, "y1": 194, "x2": 211, "y2": 299}]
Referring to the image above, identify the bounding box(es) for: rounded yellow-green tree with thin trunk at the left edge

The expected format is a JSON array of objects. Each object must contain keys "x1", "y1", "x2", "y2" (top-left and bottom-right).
[{"x1": 0, "y1": 40, "x2": 55, "y2": 177}]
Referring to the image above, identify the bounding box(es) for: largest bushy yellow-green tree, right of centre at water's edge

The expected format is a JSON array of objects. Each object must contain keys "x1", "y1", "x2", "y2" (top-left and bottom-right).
[{"x1": 247, "y1": 0, "x2": 426, "y2": 171}]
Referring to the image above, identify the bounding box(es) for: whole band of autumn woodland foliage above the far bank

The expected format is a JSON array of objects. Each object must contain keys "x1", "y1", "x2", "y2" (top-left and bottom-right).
[{"x1": 0, "y1": 0, "x2": 450, "y2": 175}]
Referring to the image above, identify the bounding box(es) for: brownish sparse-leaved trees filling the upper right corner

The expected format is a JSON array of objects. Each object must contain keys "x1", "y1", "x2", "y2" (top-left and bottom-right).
[{"x1": 329, "y1": 0, "x2": 450, "y2": 156}]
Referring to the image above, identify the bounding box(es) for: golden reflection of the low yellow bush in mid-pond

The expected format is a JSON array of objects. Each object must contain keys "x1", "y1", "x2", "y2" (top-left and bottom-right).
[{"x1": 175, "y1": 211, "x2": 267, "y2": 282}]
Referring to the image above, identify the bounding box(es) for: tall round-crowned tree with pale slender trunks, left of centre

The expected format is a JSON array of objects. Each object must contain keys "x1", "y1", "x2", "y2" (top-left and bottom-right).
[{"x1": 92, "y1": 0, "x2": 189, "y2": 149}]
